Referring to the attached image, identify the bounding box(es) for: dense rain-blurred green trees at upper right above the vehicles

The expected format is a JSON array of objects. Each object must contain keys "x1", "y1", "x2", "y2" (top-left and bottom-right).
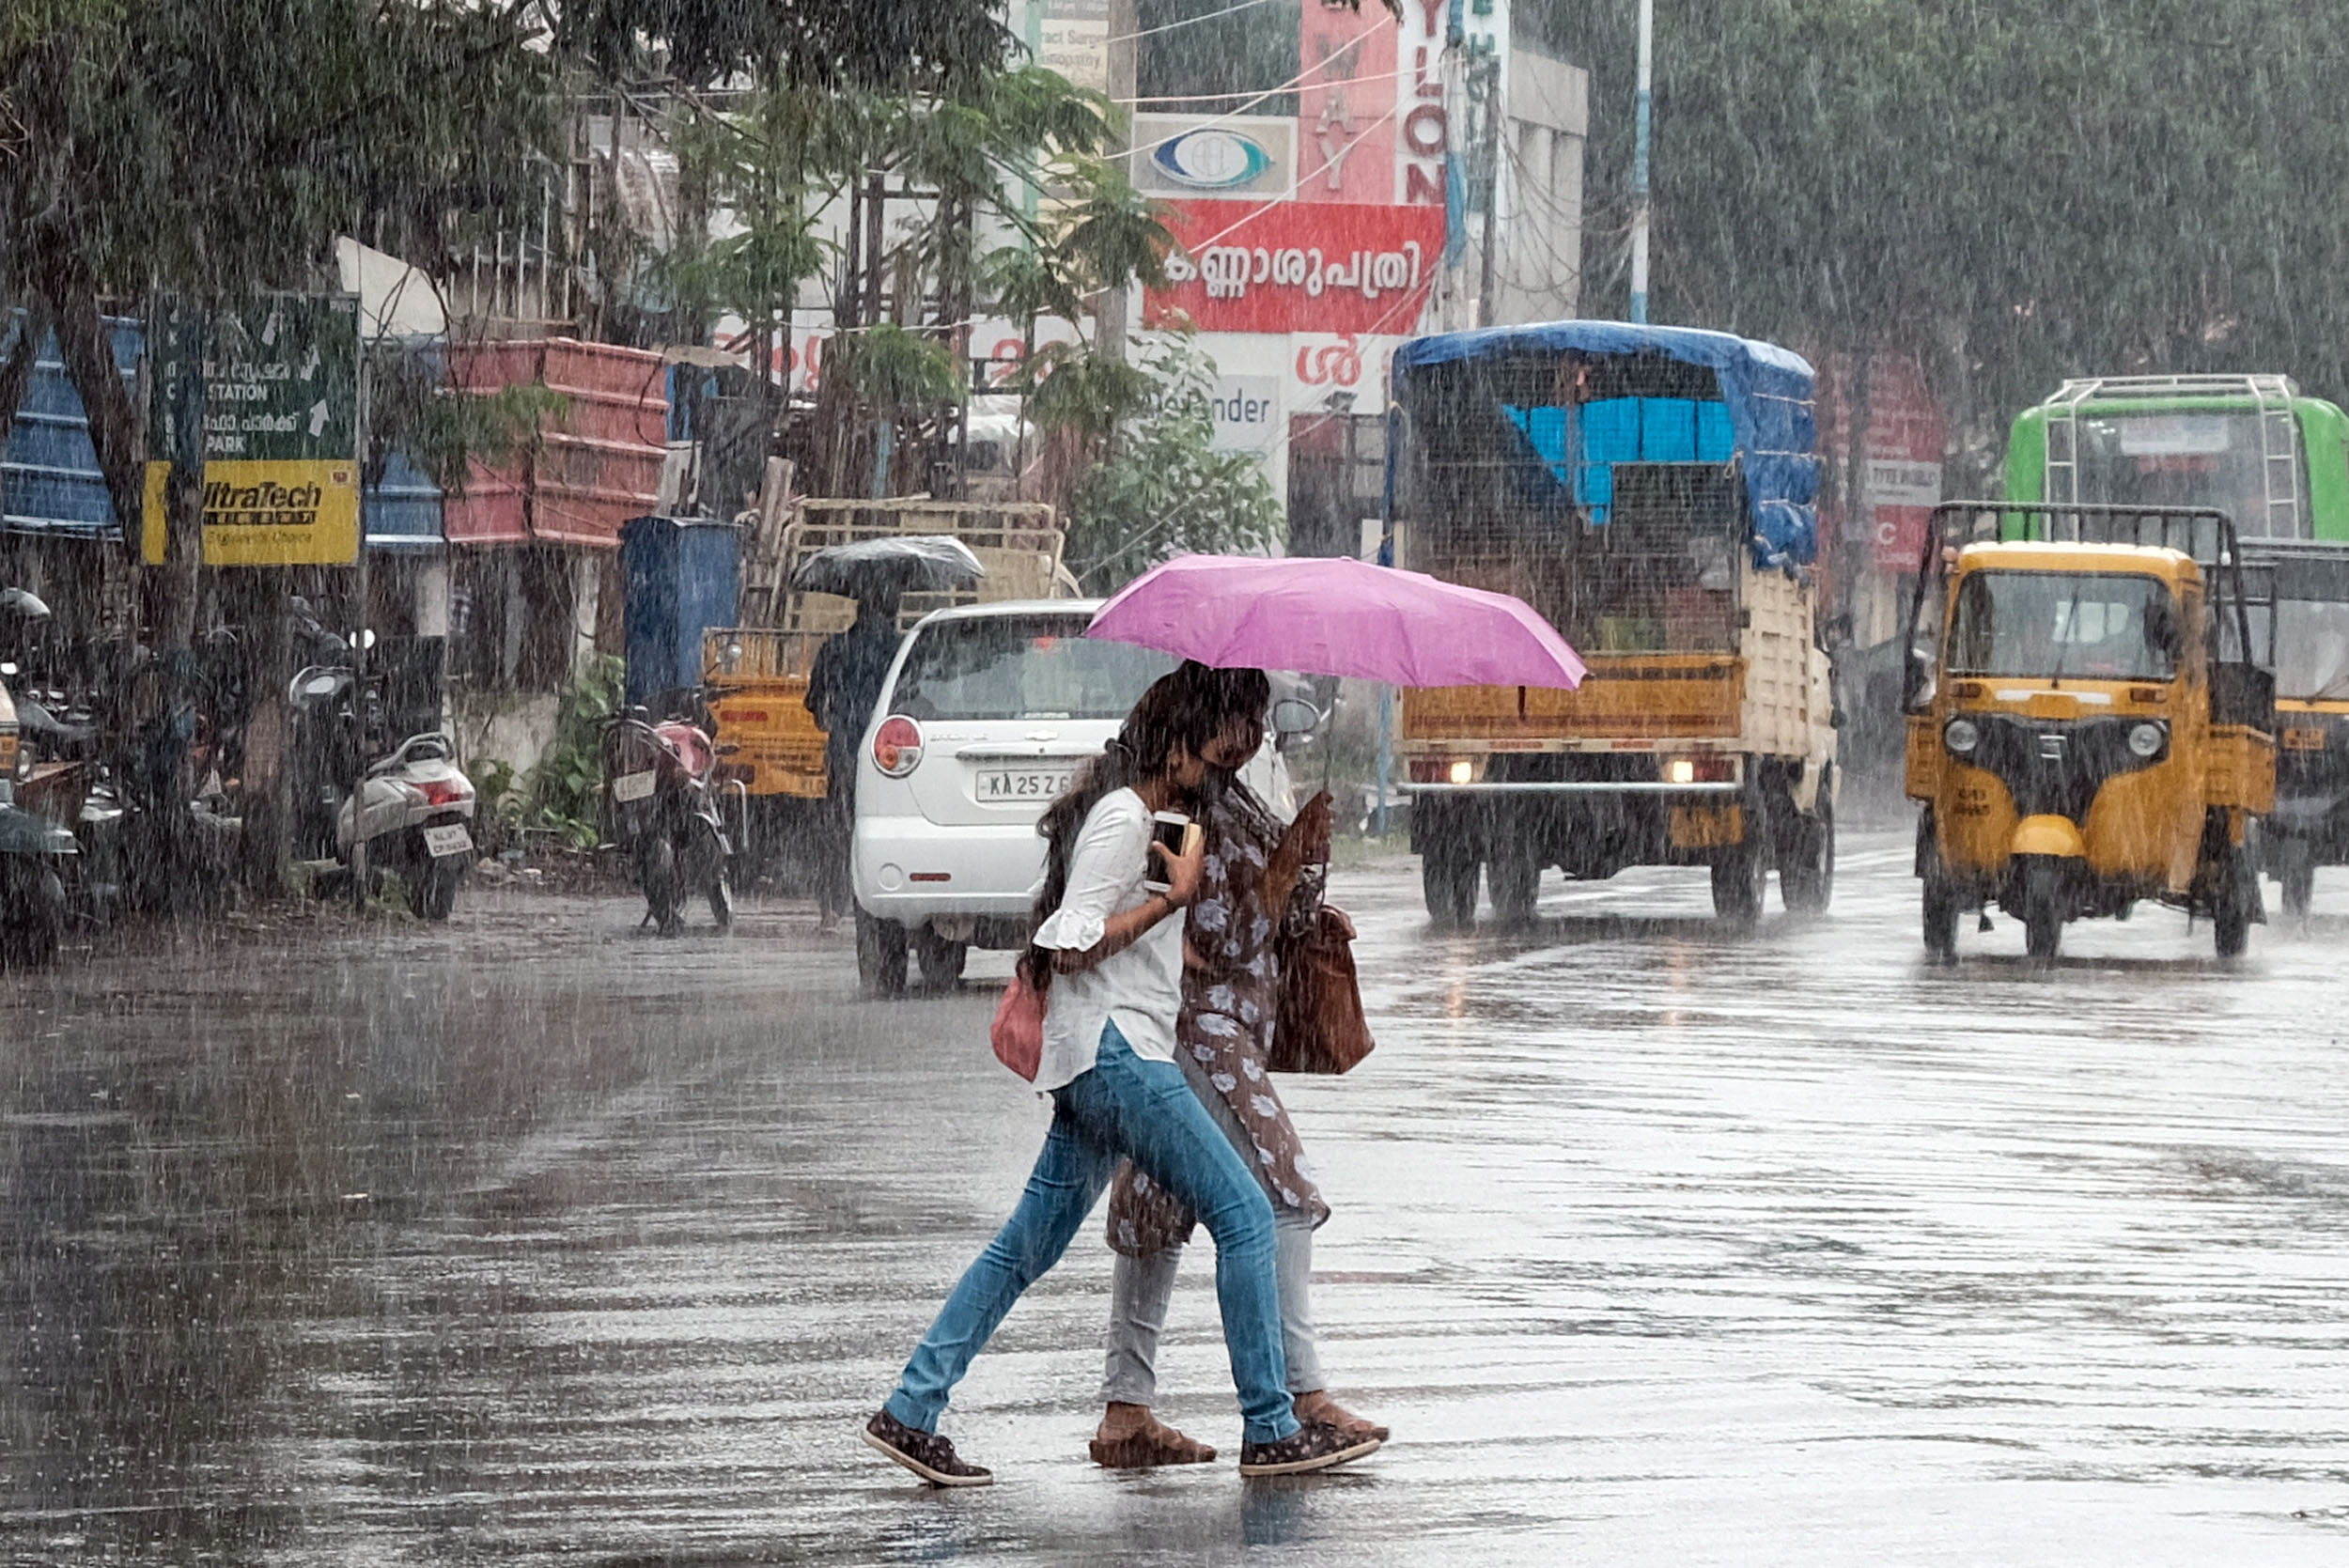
[{"x1": 1563, "y1": 0, "x2": 2349, "y2": 459}]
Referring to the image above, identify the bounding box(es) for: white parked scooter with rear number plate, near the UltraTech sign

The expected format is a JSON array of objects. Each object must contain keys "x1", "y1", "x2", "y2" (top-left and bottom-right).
[{"x1": 287, "y1": 664, "x2": 474, "y2": 920}]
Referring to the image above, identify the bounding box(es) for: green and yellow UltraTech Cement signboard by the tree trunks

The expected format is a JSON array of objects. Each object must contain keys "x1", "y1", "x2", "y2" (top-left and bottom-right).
[{"x1": 144, "y1": 293, "x2": 360, "y2": 566}]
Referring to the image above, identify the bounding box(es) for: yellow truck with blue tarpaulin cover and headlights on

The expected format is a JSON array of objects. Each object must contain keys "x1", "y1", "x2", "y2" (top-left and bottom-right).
[{"x1": 1389, "y1": 321, "x2": 1837, "y2": 924}]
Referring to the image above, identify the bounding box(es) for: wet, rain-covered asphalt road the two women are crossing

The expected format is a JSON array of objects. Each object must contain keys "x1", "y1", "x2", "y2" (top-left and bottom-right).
[{"x1": 0, "y1": 833, "x2": 2349, "y2": 1566}]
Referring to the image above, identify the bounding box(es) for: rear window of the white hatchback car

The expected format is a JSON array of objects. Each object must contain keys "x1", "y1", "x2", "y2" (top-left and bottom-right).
[{"x1": 888, "y1": 615, "x2": 1174, "y2": 719}]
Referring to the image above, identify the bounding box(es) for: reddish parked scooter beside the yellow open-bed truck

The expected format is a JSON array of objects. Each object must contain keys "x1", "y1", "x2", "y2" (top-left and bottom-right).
[{"x1": 604, "y1": 709, "x2": 733, "y2": 937}]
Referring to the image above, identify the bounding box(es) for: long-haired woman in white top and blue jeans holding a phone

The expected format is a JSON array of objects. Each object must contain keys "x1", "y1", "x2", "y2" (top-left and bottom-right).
[{"x1": 864, "y1": 676, "x2": 1379, "y2": 1486}]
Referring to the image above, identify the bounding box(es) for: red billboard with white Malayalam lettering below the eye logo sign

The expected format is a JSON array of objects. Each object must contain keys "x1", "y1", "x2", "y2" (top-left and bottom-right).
[{"x1": 1146, "y1": 199, "x2": 1445, "y2": 334}]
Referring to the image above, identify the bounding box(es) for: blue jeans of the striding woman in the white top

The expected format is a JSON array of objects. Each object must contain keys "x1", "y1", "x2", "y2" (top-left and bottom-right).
[{"x1": 886, "y1": 1023, "x2": 1297, "y2": 1444}]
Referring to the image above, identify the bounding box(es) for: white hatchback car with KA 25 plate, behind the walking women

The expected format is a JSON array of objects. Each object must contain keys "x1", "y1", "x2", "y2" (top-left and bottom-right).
[{"x1": 850, "y1": 598, "x2": 1311, "y2": 995}]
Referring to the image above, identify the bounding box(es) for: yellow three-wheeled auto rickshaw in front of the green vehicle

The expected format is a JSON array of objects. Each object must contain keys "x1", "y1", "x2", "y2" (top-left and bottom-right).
[{"x1": 1903, "y1": 500, "x2": 2277, "y2": 960}]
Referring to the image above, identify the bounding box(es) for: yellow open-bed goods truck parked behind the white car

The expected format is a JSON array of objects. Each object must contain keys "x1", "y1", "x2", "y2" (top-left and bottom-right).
[{"x1": 703, "y1": 498, "x2": 1076, "y2": 863}]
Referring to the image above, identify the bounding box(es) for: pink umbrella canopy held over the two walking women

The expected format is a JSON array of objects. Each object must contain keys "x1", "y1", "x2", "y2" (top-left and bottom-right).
[{"x1": 1085, "y1": 556, "x2": 1583, "y2": 691}]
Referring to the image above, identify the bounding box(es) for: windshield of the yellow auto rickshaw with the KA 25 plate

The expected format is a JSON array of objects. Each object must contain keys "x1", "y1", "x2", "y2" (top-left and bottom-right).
[{"x1": 1948, "y1": 568, "x2": 2180, "y2": 681}]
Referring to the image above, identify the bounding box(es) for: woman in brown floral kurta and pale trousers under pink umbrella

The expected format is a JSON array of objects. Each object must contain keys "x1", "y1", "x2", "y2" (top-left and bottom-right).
[{"x1": 1093, "y1": 672, "x2": 1386, "y2": 1467}]
